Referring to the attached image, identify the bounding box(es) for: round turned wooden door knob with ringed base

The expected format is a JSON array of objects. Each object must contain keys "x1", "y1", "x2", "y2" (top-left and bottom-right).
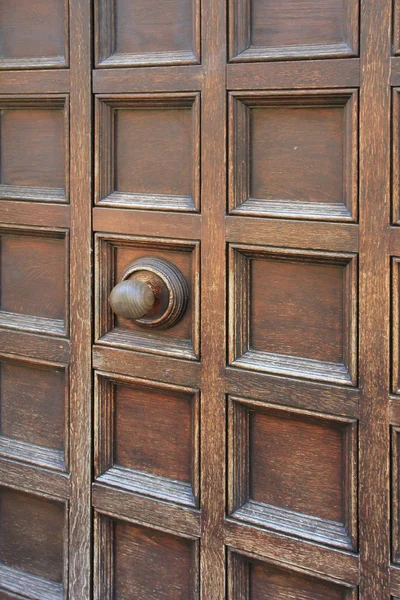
[{"x1": 109, "y1": 256, "x2": 189, "y2": 329}]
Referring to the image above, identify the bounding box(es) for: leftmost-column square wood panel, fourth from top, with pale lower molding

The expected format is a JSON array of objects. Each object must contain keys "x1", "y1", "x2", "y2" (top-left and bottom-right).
[{"x1": 0, "y1": 356, "x2": 68, "y2": 470}]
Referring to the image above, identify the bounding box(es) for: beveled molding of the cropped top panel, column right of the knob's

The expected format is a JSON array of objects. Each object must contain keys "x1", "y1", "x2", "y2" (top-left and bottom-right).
[{"x1": 229, "y1": 0, "x2": 359, "y2": 62}]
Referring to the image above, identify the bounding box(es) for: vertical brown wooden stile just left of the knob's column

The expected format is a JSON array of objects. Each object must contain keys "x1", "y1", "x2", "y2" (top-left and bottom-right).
[{"x1": 69, "y1": 0, "x2": 92, "y2": 600}]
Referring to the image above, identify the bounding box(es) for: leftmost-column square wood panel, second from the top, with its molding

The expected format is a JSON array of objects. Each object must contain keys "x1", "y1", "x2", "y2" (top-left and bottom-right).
[{"x1": 0, "y1": 96, "x2": 69, "y2": 202}]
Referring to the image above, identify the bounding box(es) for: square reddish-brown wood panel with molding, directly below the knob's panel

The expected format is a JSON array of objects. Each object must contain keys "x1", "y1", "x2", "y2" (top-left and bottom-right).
[{"x1": 95, "y1": 373, "x2": 199, "y2": 506}]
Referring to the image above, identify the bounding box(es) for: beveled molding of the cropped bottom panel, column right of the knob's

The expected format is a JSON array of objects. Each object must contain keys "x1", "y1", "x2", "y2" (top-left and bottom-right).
[{"x1": 227, "y1": 547, "x2": 358, "y2": 600}]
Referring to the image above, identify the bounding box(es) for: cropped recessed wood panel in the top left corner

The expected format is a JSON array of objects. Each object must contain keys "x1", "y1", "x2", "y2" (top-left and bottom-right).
[{"x1": 0, "y1": 0, "x2": 68, "y2": 68}]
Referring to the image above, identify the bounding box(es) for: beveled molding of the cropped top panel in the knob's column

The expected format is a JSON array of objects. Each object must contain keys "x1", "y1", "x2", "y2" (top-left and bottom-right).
[{"x1": 94, "y1": 0, "x2": 201, "y2": 68}]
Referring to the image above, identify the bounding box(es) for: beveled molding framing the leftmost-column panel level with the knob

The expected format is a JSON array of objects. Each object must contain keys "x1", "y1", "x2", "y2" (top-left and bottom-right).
[{"x1": 0, "y1": 223, "x2": 70, "y2": 340}]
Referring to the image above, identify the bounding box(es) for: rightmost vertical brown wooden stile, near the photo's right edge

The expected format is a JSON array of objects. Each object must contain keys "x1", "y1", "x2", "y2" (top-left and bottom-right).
[{"x1": 359, "y1": 0, "x2": 391, "y2": 600}]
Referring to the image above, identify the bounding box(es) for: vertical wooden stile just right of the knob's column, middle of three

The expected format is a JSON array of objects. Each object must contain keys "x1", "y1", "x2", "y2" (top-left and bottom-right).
[{"x1": 200, "y1": 0, "x2": 226, "y2": 600}]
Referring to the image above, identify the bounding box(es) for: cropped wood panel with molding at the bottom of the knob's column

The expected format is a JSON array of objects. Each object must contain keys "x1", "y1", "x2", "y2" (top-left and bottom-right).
[{"x1": 94, "y1": 515, "x2": 199, "y2": 600}]
